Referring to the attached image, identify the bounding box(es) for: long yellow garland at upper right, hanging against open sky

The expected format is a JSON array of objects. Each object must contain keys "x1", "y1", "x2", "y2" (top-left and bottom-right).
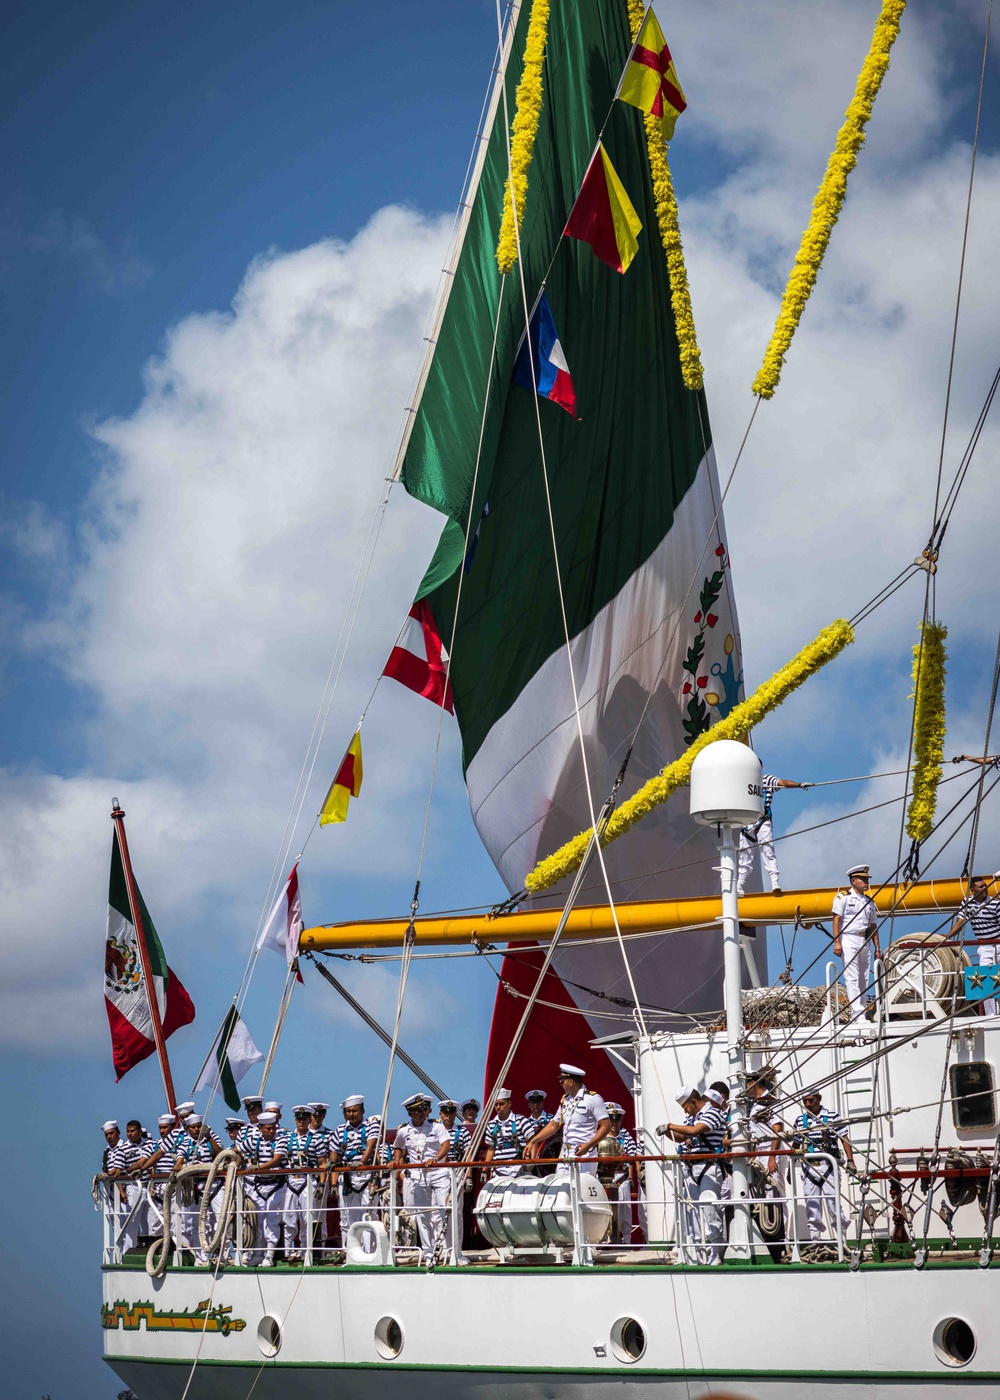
[{"x1": 752, "y1": 0, "x2": 906, "y2": 399}]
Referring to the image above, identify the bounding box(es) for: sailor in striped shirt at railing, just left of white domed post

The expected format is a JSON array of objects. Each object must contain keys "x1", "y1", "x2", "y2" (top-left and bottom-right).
[{"x1": 657, "y1": 1085, "x2": 725, "y2": 1264}]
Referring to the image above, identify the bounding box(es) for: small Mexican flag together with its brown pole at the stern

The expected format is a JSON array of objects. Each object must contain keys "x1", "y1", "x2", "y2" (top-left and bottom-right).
[{"x1": 104, "y1": 802, "x2": 195, "y2": 1092}]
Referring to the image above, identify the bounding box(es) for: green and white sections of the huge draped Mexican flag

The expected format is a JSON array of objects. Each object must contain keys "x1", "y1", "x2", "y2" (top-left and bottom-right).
[{"x1": 392, "y1": 0, "x2": 742, "y2": 1052}]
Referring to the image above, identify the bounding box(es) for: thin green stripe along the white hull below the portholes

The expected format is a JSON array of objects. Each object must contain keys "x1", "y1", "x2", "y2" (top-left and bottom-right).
[{"x1": 102, "y1": 1352, "x2": 1000, "y2": 1382}]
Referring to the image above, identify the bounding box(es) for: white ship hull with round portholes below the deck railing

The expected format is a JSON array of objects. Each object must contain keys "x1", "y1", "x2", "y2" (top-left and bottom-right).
[{"x1": 104, "y1": 1261, "x2": 1000, "y2": 1400}]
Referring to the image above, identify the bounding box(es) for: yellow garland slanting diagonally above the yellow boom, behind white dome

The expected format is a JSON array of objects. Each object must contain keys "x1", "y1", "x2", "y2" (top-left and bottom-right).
[{"x1": 524, "y1": 617, "x2": 854, "y2": 895}]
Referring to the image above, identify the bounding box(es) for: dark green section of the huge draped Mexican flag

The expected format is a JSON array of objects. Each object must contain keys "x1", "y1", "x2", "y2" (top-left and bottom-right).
[{"x1": 402, "y1": 0, "x2": 711, "y2": 764}]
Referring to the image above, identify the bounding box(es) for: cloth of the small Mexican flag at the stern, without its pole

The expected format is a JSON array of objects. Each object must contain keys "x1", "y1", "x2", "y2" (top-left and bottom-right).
[{"x1": 104, "y1": 827, "x2": 195, "y2": 1079}]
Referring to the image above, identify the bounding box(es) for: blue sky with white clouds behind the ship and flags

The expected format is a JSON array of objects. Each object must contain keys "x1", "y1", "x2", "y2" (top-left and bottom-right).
[{"x1": 0, "y1": 0, "x2": 1000, "y2": 1400}]
